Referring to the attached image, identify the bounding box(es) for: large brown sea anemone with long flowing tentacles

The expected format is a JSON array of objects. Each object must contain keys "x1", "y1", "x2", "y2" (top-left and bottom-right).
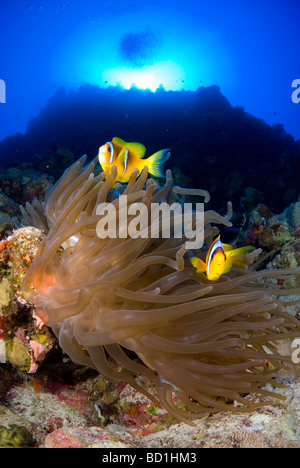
[{"x1": 19, "y1": 154, "x2": 300, "y2": 423}]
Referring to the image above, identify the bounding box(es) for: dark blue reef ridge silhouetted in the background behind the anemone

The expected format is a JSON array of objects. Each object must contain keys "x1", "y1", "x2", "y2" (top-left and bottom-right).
[{"x1": 0, "y1": 85, "x2": 300, "y2": 213}]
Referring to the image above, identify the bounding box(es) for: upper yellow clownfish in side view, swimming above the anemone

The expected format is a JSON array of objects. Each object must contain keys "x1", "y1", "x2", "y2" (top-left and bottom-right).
[{"x1": 98, "y1": 137, "x2": 171, "y2": 183}]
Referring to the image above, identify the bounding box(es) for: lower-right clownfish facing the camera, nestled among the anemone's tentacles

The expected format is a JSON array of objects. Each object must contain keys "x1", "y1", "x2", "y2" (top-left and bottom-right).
[{"x1": 190, "y1": 236, "x2": 254, "y2": 281}]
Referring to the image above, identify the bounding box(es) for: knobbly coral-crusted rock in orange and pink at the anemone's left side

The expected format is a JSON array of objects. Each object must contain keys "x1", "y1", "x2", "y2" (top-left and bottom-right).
[{"x1": 0, "y1": 227, "x2": 55, "y2": 373}]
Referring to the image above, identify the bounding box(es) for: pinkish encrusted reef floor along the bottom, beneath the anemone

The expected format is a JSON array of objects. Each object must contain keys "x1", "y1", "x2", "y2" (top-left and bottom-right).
[{"x1": 0, "y1": 360, "x2": 300, "y2": 449}]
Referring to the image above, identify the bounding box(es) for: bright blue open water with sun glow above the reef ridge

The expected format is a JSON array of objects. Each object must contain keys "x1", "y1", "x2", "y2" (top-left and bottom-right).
[{"x1": 0, "y1": 0, "x2": 300, "y2": 144}]
